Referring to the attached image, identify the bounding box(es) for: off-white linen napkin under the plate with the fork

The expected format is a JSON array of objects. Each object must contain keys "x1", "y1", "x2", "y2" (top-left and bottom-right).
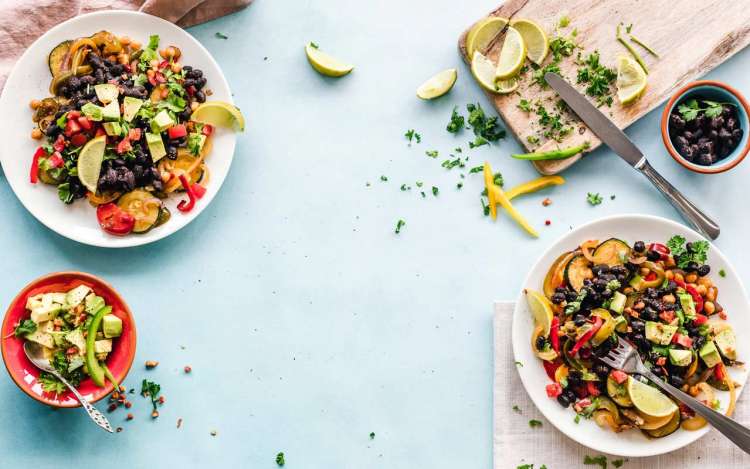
[{"x1": 492, "y1": 301, "x2": 750, "y2": 469}]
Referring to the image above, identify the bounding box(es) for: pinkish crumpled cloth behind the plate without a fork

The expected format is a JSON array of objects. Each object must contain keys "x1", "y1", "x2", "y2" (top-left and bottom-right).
[{"x1": 0, "y1": 0, "x2": 252, "y2": 89}]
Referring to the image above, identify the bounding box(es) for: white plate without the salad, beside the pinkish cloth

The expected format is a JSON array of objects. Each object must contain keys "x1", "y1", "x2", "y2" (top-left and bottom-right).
[{"x1": 0, "y1": 11, "x2": 236, "y2": 248}]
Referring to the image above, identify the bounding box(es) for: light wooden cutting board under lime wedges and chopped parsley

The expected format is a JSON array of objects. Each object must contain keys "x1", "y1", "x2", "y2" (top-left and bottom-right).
[{"x1": 458, "y1": 0, "x2": 750, "y2": 174}]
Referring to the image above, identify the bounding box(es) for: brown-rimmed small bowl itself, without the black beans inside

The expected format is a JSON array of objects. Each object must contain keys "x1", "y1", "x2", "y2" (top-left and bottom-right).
[{"x1": 661, "y1": 80, "x2": 750, "y2": 174}]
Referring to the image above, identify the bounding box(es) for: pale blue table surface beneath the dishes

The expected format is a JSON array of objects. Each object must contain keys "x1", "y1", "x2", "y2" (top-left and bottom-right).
[{"x1": 0, "y1": 0, "x2": 750, "y2": 468}]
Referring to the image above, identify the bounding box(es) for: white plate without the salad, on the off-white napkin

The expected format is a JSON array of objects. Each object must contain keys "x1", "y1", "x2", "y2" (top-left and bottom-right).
[{"x1": 513, "y1": 215, "x2": 750, "y2": 457}]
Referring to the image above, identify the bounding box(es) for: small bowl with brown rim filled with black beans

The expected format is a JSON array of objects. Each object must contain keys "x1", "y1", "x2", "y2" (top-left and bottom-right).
[{"x1": 661, "y1": 80, "x2": 750, "y2": 174}]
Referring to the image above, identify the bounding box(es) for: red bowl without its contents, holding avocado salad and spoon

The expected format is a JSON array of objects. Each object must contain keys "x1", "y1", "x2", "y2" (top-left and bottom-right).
[{"x1": 0, "y1": 272, "x2": 136, "y2": 407}]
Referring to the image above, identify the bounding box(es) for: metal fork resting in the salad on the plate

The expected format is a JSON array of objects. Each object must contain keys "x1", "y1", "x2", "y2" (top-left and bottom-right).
[{"x1": 599, "y1": 336, "x2": 750, "y2": 454}]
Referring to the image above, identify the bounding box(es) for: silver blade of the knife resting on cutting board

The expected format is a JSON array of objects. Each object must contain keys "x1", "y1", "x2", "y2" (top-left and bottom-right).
[{"x1": 544, "y1": 72, "x2": 646, "y2": 168}]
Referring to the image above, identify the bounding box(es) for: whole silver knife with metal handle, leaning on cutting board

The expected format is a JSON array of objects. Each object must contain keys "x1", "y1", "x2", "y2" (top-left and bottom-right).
[{"x1": 544, "y1": 72, "x2": 720, "y2": 239}]
